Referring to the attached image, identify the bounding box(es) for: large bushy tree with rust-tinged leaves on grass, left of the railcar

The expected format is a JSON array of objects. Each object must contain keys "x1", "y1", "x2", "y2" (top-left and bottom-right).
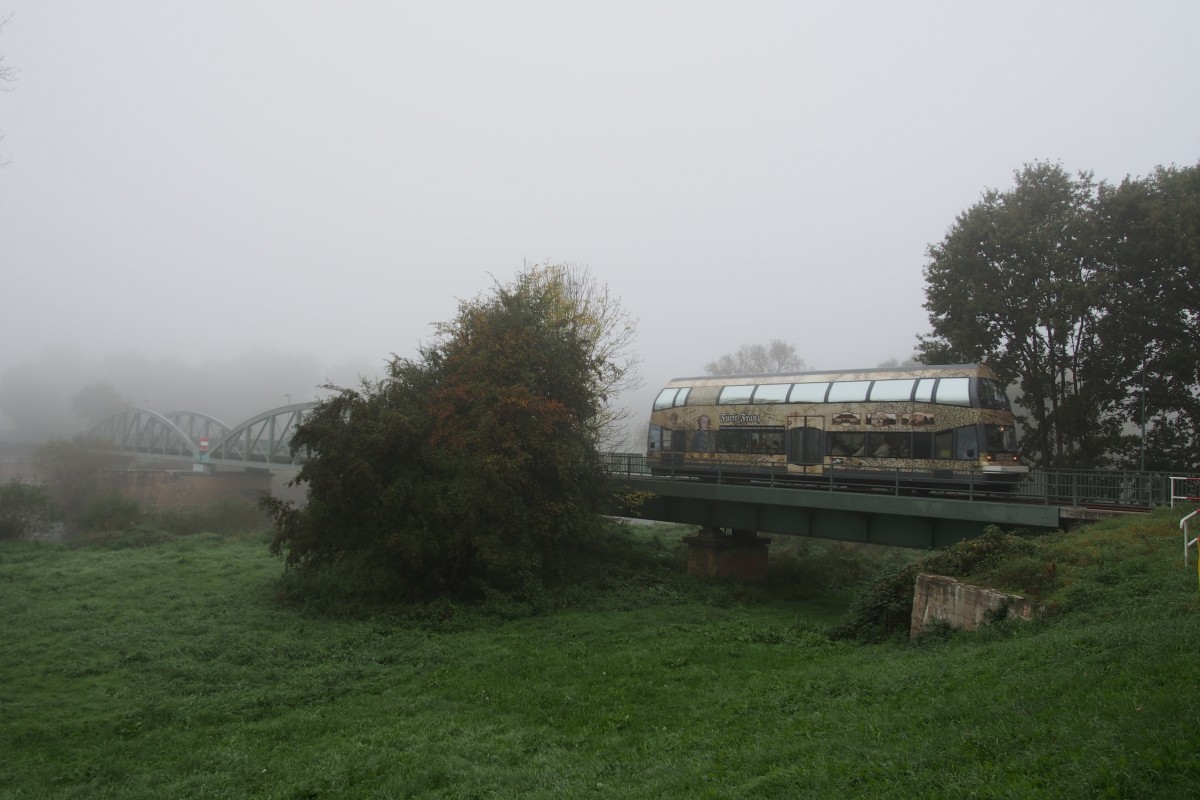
[{"x1": 264, "y1": 265, "x2": 632, "y2": 595}]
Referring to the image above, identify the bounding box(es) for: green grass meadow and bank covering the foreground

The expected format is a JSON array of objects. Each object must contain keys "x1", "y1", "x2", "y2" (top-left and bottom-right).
[{"x1": 0, "y1": 512, "x2": 1200, "y2": 800}]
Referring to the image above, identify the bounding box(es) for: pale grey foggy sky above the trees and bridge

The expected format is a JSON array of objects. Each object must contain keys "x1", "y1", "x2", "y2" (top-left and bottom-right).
[{"x1": 0, "y1": 0, "x2": 1200, "y2": 438}]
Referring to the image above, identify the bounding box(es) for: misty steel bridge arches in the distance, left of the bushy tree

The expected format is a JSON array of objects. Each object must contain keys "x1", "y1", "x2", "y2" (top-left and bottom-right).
[{"x1": 88, "y1": 403, "x2": 317, "y2": 470}]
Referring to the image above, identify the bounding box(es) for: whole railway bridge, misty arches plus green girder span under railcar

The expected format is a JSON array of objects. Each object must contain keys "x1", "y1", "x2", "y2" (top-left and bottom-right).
[{"x1": 89, "y1": 403, "x2": 1200, "y2": 547}]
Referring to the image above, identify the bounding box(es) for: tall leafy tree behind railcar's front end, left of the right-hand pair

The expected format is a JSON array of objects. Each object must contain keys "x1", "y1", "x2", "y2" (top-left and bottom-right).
[{"x1": 918, "y1": 163, "x2": 1120, "y2": 468}]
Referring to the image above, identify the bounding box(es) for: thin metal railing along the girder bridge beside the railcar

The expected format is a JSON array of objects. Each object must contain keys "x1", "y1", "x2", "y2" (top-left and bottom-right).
[{"x1": 595, "y1": 453, "x2": 1200, "y2": 509}]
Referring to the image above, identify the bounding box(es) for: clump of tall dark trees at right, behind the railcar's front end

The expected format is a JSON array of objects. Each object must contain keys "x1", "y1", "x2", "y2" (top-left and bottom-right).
[{"x1": 919, "y1": 163, "x2": 1200, "y2": 470}]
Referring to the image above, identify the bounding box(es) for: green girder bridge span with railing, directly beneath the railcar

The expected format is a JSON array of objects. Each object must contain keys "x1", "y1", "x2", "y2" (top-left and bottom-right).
[{"x1": 610, "y1": 455, "x2": 1200, "y2": 548}]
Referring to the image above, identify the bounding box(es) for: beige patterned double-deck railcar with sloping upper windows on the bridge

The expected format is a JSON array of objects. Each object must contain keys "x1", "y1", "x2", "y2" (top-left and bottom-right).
[{"x1": 646, "y1": 365, "x2": 1028, "y2": 488}]
